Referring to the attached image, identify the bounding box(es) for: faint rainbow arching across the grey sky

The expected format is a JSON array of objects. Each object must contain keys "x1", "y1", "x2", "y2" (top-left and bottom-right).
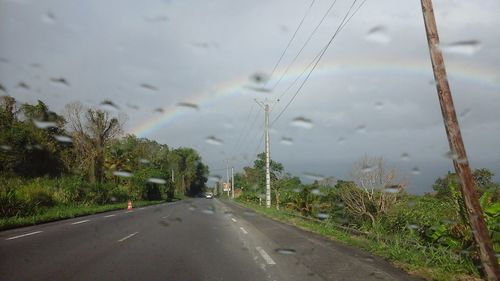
[{"x1": 130, "y1": 58, "x2": 500, "y2": 137}]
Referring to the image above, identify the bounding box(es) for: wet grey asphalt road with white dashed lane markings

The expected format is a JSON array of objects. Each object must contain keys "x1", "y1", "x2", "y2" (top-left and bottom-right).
[{"x1": 0, "y1": 198, "x2": 417, "y2": 281}]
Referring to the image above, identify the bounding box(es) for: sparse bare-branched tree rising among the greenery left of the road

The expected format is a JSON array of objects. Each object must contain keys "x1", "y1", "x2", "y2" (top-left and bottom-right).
[{"x1": 66, "y1": 103, "x2": 122, "y2": 183}]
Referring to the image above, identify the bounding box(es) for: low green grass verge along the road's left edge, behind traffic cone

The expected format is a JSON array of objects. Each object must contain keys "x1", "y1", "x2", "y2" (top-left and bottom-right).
[{"x1": 0, "y1": 200, "x2": 165, "y2": 230}]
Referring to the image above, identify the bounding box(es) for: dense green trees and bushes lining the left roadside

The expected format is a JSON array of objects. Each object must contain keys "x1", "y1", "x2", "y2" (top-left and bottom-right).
[{"x1": 0, "y1": 96, "x2": 208, "y2": 218}]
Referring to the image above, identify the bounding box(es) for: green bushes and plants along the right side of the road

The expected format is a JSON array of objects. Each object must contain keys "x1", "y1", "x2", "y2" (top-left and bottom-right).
[{"x1": 235, "y1": 154, "x2": 500, "y2": 276}]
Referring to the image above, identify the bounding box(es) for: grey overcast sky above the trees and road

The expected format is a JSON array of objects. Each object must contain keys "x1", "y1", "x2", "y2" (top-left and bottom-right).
[{"x1": 0, "y1": 0, "x2": 500, "y2": 193}]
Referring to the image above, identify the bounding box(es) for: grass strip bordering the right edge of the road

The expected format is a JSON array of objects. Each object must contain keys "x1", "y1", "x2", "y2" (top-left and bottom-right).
[{"x1": 234, "y1": 201, "x2": 482, "y2": 281}]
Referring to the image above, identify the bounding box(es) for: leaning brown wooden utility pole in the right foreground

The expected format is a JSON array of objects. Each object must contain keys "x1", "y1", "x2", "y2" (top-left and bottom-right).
[{"x1": 421, "y1": 0, "x2": 500, "y2": 280}]
